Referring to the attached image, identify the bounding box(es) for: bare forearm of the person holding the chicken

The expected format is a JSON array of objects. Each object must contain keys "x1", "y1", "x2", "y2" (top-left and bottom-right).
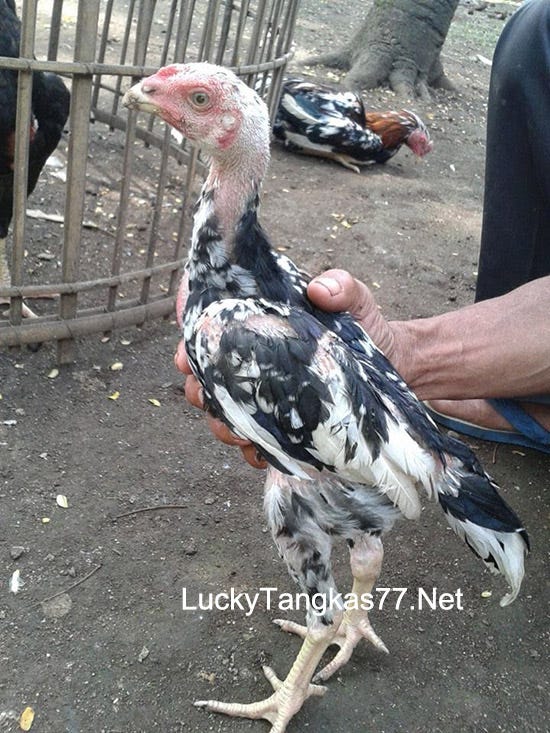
[{"x1": 388, "y1": 277, "x2": 550, "y2": 399}]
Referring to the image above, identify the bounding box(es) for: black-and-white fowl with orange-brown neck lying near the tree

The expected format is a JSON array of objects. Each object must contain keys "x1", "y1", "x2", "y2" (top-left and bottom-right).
[{"x1": 273, "y1": 79, "x2": 432, "y2": 173}]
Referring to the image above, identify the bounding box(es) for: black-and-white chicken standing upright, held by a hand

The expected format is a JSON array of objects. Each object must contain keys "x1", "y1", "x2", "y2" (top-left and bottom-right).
[{"x1": 124, "y1": 63, "x2": 527, "y2": 733}]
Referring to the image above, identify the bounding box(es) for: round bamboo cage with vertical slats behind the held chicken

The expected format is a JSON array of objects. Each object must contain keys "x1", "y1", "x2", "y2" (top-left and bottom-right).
[{"x1": 0, "y1": 0, "x2": 299, "y2": 363}]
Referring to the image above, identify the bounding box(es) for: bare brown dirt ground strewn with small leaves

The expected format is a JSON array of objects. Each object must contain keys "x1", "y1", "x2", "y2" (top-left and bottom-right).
[{"x1": 0, "y1": 0, "x2": 550, "y2": 733}]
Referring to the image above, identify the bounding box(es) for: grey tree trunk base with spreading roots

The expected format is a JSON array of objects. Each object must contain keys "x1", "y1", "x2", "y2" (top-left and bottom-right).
[{"x1": 309, "y1": 0, "x2": 459, "y2": 97}]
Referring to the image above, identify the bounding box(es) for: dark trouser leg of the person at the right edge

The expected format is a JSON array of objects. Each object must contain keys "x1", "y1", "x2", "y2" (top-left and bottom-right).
[{"x1": 476, "y1": 0, "x2": 550, "y2": 300}]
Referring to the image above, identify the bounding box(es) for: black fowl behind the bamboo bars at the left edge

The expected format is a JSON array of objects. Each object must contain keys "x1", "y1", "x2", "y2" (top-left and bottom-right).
[{"x1": 0, "y1": 0, "x2": 70, "y2": 316}]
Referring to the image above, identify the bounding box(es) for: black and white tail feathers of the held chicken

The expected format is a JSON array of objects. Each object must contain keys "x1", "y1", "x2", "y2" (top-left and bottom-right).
[{"x1": 438, "y1": 465, "x2": 529, "y2": 606}]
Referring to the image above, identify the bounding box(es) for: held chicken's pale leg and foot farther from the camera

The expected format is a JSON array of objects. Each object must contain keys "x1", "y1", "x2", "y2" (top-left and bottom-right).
[{"x1": 274, "y1": 534, "x2": 388, "y2": 682}]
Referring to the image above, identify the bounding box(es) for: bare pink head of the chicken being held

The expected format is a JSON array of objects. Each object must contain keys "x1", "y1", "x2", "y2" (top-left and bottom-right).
[{"x1": 123, "y1": 63, "x2": 269, "y2": 158}]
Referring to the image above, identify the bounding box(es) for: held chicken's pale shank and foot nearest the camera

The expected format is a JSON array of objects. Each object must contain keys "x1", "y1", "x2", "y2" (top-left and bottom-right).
[{"x1": 195, "y1": 611, "x2": 342, "y2": 733}]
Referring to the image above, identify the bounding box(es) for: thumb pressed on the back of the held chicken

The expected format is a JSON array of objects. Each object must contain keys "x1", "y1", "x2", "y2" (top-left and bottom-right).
[{"x1": 307, "y1": 270, "x2": 378, "y2": 321}]
